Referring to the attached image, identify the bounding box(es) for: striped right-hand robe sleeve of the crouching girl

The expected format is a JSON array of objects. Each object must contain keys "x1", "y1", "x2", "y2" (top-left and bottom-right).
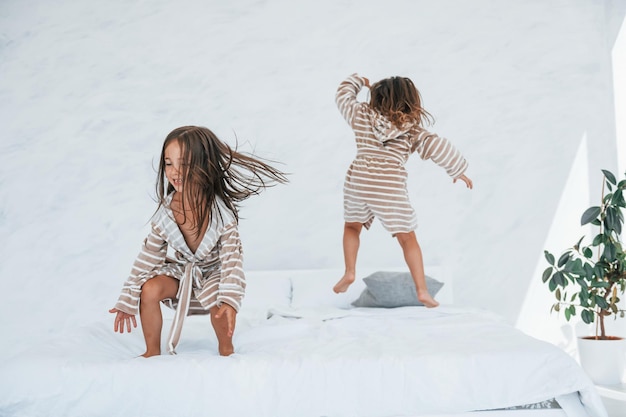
[{"x1": 217, "y1": 220, "x2": 246, "y2": 312}]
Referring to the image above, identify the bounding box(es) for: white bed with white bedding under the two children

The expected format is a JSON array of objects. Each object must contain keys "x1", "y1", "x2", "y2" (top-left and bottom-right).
[{"x1": 0, "y1": 268, "x2": 606, "y2": 417}]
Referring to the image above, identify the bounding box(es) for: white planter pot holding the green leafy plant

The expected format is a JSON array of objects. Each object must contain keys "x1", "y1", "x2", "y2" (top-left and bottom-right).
[{"x1": 578, "y1": 337, "x2": 626, "y2": 385}]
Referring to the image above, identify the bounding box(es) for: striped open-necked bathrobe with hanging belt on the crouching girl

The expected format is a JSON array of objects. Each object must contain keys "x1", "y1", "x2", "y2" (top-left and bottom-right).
[{"x1": 115, "y1": 193, "x2": 246, "y2": 354}]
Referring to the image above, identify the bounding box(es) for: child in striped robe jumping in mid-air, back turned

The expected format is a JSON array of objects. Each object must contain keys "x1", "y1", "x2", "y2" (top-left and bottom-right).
[{"x1": 333, "y1": 74, "x2": 473, "y2": 307}]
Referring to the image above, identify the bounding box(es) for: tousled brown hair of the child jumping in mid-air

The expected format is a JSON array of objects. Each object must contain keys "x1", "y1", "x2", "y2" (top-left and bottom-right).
[{"x1": 370, "y1": 77, "x2": 434, "y2": 129}]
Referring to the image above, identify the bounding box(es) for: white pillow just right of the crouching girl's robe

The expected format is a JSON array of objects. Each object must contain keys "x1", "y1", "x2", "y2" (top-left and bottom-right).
[{"x1": 239, "y1": 271, "x2": 291, "y2": 317}]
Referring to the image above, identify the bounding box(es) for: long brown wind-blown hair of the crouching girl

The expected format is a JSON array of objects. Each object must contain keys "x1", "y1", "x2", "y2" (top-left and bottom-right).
[{"x1": 156, "y1": 126, "x2": 288, "y2": 237}]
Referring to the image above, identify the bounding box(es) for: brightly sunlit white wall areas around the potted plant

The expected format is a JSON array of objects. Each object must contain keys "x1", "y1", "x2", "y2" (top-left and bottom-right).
[{"x1": 517, "y1": 2, "x2": 626, "y2": 355}]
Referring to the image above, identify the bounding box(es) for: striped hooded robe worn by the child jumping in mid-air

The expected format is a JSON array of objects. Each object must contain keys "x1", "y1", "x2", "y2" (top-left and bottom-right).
[{"x1": 335, "y1": 74, "x2": 467, "y2": 235}]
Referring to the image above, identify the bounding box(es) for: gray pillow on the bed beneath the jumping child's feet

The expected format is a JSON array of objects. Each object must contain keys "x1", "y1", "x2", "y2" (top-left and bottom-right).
[{"x1": 352, "y1": 271, "x2": 443, "y2": 308}]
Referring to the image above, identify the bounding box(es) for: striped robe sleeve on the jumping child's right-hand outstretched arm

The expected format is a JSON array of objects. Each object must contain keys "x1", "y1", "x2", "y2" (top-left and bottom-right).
[{"x1": 411, "y1": 128, "x2": 468, "y2": 178}]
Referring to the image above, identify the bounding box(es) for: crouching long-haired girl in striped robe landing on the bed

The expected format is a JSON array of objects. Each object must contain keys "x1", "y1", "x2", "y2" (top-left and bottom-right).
[{"x1": 109, "y1": 126, "x2": 287, "y2": 357}]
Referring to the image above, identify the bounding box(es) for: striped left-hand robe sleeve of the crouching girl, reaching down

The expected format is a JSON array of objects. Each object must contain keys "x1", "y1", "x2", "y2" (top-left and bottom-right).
[{"x1": 115, "y1": 226, "x2": 167, "y2": 314}]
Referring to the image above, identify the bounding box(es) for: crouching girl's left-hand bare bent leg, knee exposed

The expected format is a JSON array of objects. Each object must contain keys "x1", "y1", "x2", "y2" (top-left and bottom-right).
[{"x1": 139, "y1": 275, "x2": 178, "y2": 358}]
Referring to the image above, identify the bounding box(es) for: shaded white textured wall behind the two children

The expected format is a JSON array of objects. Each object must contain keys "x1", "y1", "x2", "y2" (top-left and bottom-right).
[{"x1": 0, "y1": 0, "x2": 624, "y2": 349}]
